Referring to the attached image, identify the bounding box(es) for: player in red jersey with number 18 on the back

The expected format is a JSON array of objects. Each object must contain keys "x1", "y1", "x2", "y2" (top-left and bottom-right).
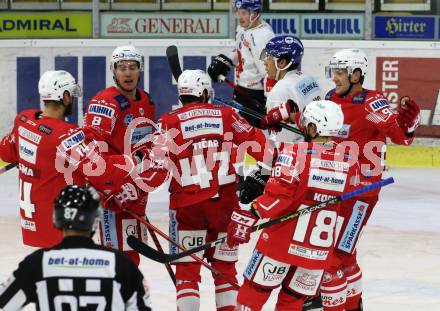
[{"x1": 228, "y1": 100, "x2": 357, "y2": 311}]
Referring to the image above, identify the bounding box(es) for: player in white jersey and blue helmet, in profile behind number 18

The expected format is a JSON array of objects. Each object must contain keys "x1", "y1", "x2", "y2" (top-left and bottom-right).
[{"x1": 261, "y1": 36, "x2": 323, "y2": 142}]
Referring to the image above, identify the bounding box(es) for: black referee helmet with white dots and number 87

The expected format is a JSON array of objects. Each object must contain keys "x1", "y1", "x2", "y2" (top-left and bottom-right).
[{"x1": 53, "y1": 185, "x2": 101, "y2": 231}]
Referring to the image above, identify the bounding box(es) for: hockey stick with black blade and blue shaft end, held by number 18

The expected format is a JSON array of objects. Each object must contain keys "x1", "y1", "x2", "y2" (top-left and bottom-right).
[{"x1": 126, "y1": 177, "x2": 394, "y2": 263}]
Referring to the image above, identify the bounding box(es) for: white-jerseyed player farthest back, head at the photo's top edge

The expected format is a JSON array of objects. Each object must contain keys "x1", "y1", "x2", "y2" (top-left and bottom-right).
[{"x1": 208, "y1": 0, "x2": 275, "y2": 126}]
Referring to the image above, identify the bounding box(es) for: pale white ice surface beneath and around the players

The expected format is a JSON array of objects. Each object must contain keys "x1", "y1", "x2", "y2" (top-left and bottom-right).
[{"x1": 0, "y1": 168, "x2": 440, "y2": 311}]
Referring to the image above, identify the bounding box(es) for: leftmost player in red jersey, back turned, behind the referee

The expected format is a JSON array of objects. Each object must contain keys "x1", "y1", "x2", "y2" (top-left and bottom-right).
[{"x1": 0, "y1": 70, "x2": 141, "y2": 247}]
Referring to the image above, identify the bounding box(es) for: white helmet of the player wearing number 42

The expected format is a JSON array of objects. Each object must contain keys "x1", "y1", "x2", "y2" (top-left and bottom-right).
[{"x1": 177, "y1": 69, "x2": 214, "y2": 98}]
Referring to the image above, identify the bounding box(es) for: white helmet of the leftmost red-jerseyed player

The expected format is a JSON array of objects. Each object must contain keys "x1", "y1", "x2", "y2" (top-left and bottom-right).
[{"x1": 38, "y1": 70, "x2": 82, "y2": 101}]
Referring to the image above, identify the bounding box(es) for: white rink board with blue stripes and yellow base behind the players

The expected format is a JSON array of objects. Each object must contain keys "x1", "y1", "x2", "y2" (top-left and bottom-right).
[{"x1": 0, "y1": 39, "x2": 440, "y2": 166}]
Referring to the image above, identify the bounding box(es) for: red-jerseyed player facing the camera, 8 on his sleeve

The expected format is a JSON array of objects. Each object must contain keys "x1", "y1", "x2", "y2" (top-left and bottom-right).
[{"x1": 84, "y1": 46, "x2": 155, "y2": 263}]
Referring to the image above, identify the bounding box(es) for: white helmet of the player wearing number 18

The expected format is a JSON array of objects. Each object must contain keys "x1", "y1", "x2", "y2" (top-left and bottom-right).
[{"x1": 301, "y1": 100, "x2": 344, "y2": 136}]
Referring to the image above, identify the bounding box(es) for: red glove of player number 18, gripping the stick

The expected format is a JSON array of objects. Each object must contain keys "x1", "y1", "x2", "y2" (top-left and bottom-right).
[{"x1": 226, "y1": 210, "x2": 258, "y2": 248}]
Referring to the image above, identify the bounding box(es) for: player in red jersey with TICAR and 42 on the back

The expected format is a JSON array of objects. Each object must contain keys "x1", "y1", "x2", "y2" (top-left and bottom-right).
[{"x1": 153, "y1": 70, "x2": 272, "y2": 311}]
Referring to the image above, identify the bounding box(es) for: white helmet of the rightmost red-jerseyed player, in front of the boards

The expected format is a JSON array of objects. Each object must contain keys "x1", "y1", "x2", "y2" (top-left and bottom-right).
[{"x1": 325, "y1": 49, "x2": 368, "y2": 78}]
